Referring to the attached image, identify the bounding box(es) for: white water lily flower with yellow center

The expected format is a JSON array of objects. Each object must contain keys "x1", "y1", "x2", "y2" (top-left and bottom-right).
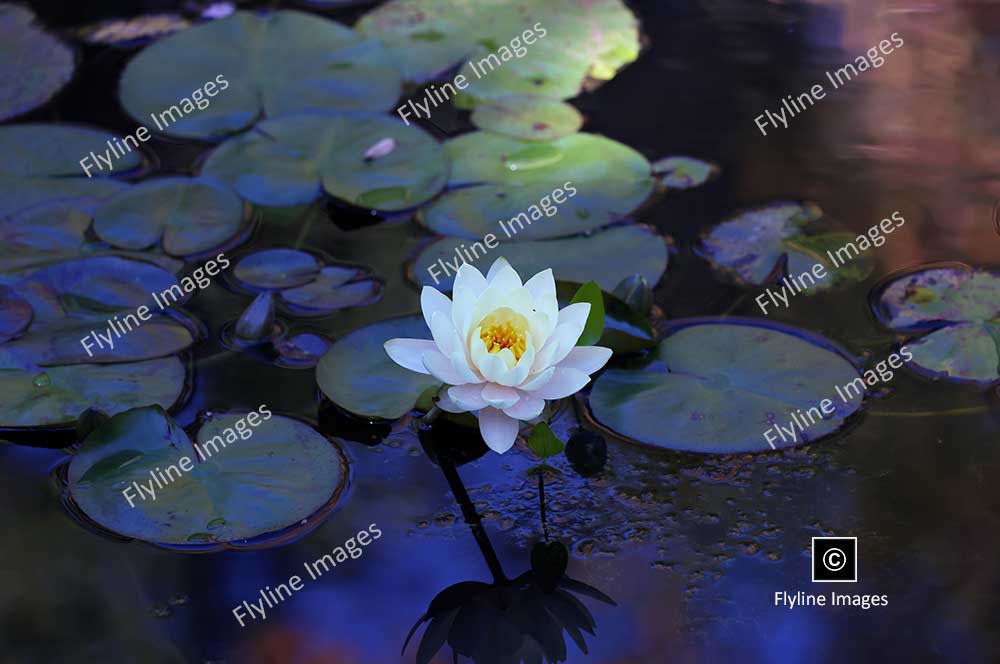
[{"x1": 385, "y1": 258, "x2": 611, "y2": 453}]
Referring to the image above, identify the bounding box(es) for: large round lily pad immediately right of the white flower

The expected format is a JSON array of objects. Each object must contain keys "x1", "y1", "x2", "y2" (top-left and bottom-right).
[{"x1": 590, "y1": 319, "x2": 861, "y2": 453}]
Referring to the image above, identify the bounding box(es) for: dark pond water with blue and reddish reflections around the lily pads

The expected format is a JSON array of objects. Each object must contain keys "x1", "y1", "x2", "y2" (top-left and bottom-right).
[{"x1": 0, "y1": 0, "x2": 1000, "y2": 664}]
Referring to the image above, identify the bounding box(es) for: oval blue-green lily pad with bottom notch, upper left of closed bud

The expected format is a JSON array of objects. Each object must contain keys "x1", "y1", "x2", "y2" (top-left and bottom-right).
[{"x1": 94, "y1": 178, "x2": 246, "y2": 256}]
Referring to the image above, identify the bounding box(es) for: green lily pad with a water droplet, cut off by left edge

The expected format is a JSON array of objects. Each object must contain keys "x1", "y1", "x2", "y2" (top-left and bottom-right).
[{"x1": 0, "y1": 356, "x2": 187, "y2": 428}]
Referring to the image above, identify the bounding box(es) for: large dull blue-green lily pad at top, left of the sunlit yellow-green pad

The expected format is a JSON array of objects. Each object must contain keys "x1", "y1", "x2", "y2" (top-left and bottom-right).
[{"x1": 120, "y1": 10, "x2": 401, "y2": 138}]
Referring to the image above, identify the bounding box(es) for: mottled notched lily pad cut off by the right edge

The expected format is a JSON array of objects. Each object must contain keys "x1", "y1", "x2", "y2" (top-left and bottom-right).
[{"x1": 876, "y1": 264, "x2": 1000, "y2": 384}]
